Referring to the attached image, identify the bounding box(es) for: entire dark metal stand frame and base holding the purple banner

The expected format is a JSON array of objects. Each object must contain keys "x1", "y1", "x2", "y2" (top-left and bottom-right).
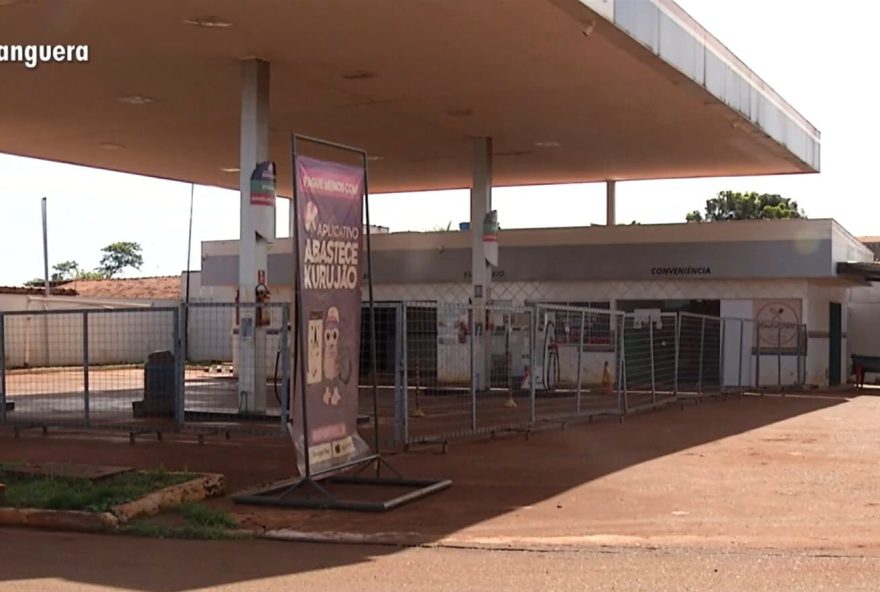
[{"x1": 232, "y1": 134, "x2": 452, "y2": 512}]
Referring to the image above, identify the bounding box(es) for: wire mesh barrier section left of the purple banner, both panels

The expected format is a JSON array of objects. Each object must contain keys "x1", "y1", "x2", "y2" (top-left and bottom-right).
[{"x1": 0, "y1": 303, "x2": 290, "y2": 432}]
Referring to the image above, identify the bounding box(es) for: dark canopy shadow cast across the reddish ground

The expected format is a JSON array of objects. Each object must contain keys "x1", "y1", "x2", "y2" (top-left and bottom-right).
[{"x1": 0, "y1": 394, "x2": 848, "y2": 591}]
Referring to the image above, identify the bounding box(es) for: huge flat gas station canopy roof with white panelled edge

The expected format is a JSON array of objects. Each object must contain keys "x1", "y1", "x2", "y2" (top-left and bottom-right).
[{"x1": 0, "y1": 0, "x2": 819, "y2": 194}]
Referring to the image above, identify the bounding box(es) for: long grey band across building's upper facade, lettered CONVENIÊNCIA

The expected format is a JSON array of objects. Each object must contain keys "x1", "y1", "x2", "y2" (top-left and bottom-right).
[{"x1": 202, "y1": 240, "x2": 832, "y2": 286}]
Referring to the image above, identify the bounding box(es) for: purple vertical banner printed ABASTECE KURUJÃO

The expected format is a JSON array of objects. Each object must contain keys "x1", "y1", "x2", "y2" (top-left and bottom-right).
[{"x1": 293, "y1": 156, "x2": 369, "y2": 474}]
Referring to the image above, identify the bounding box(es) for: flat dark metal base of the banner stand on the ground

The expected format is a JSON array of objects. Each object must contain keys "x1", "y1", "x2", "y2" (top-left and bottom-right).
[{"x1": 232, "y1": 455, "x2": 452, "y2": 512}]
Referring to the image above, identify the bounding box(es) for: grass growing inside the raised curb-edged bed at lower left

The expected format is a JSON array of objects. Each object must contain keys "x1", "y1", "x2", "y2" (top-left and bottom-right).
[{"x1": 0, "y1": 466, "x2": 195, "y2": 512}]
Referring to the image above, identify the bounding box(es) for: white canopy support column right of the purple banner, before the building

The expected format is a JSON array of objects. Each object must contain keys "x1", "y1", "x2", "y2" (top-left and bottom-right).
[{"x1": 470, "y1": 138, "x2": 492, "y2": 390}]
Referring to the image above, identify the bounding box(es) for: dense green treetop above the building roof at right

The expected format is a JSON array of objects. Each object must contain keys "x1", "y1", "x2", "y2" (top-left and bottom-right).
[{"x1": 685, "y1": 191, "x2": 806, "y2": 222}]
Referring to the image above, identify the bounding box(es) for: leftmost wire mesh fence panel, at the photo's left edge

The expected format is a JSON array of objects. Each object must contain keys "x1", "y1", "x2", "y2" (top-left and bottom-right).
[{"x1": 2, "y1": 308, "x2": 178, "y2": 427}]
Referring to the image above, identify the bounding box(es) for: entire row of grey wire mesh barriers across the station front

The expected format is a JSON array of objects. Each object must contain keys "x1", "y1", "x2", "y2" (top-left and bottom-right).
[{"x1": 0, "y1": 300, "x2": 808, "y2": 446}]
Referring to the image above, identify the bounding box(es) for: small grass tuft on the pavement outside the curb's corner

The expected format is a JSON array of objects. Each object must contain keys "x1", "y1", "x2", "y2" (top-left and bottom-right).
[{"x1": 121, "y1": 502, "x2": 241, "y2": 540}]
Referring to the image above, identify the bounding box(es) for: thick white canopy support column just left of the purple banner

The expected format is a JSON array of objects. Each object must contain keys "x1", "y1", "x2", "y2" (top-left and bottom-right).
[{"x1": 238, "y1": 59, "x2": 275, "y2": 413}]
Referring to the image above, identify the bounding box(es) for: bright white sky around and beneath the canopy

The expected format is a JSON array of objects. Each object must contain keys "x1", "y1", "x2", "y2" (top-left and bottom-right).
[{"x1": 0, "y1": 0, "x2": 880, "y2": 286}]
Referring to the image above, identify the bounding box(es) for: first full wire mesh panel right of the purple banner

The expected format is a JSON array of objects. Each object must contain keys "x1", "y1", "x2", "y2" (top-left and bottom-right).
[{"x1": 400, "y1": 302, "x2": 534, "y2": 444}]
